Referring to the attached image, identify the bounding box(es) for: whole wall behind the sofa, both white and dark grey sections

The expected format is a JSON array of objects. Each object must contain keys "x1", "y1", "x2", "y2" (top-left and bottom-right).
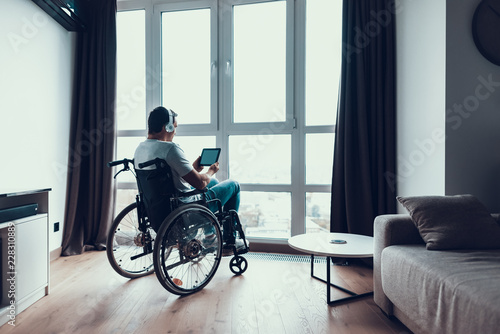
[{"x1": 397, "y1": 0, "x2": 500, "y2": 212}]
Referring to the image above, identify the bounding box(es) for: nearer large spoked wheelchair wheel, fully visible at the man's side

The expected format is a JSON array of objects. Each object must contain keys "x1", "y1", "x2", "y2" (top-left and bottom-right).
[{"x1": 153, "y1": 204, "x2": 222, "y2": 295}]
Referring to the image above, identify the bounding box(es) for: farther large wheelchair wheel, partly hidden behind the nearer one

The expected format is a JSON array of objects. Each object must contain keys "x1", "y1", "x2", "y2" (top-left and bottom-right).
[{"x1": 106, "y1": 203, "x2": 156, "y2": 278}]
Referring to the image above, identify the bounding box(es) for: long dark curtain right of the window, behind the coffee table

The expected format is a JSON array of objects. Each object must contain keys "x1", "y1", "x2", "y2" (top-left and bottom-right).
[{"x1": 330, "y1": 0, "x2": 400, "y2": 236}]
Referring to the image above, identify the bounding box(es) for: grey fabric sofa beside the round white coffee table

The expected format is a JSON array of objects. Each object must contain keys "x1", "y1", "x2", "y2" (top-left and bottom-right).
[{"x1": 373, "y1": 197, "x2": 500, "y2": 334}]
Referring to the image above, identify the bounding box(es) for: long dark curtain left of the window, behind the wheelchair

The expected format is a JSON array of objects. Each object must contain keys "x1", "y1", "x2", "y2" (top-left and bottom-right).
[{"x1": 62, "y1": 0, "x2": 116, "y2": 255}]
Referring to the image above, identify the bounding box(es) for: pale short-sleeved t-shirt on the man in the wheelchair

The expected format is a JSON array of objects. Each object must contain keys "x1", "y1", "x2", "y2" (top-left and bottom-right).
[{"x1": 134, "y1": 139, "x2": 193, "y2": 192}]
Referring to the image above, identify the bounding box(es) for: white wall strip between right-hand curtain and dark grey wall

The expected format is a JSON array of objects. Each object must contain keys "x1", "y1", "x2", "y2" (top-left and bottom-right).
[{"x1": 396, "y1": 0, "x2": 446, "y2": 212}]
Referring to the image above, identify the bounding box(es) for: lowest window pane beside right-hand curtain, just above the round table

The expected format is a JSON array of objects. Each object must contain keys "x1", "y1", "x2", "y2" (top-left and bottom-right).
[{"x1": 306, "y1": 193, "x2": 331, "y2": 233}]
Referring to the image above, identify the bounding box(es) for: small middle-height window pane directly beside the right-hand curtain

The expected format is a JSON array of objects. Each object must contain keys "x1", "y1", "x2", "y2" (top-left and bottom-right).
[{"x1": 306, "y1": 133, "x2": 335, "y2": 184}]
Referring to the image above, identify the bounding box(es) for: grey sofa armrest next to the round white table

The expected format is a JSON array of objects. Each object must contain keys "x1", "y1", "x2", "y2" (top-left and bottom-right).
[{"x1": 373, "y1": 214, "x2": 425, "y2": 315}]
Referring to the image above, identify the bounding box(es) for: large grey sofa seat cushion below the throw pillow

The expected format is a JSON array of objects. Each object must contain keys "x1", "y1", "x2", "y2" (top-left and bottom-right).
[{"x1": 381, "y1": 245, "x2": 500, "y2": 334}]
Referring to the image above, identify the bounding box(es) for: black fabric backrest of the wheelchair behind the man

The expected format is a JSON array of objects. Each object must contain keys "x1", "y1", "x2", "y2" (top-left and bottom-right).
[{"x1": 135, "y1": 158, "x2": 177, "y2": 231}]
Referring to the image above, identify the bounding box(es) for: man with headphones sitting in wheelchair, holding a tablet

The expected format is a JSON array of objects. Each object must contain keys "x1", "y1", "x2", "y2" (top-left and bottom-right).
[{"x1": 134, "y1": 106, "x2": 248, "y2": 256}]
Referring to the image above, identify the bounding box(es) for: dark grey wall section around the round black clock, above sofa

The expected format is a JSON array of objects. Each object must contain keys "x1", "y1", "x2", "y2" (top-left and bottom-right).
[{"x1": 446, "y1": 0, "x2": 500, "y2": 212}]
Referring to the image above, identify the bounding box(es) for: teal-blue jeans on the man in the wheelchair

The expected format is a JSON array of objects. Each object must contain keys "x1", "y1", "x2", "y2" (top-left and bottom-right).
[{"x1": 205, "y1": 178, "x2": 240, "y2": 241}]
